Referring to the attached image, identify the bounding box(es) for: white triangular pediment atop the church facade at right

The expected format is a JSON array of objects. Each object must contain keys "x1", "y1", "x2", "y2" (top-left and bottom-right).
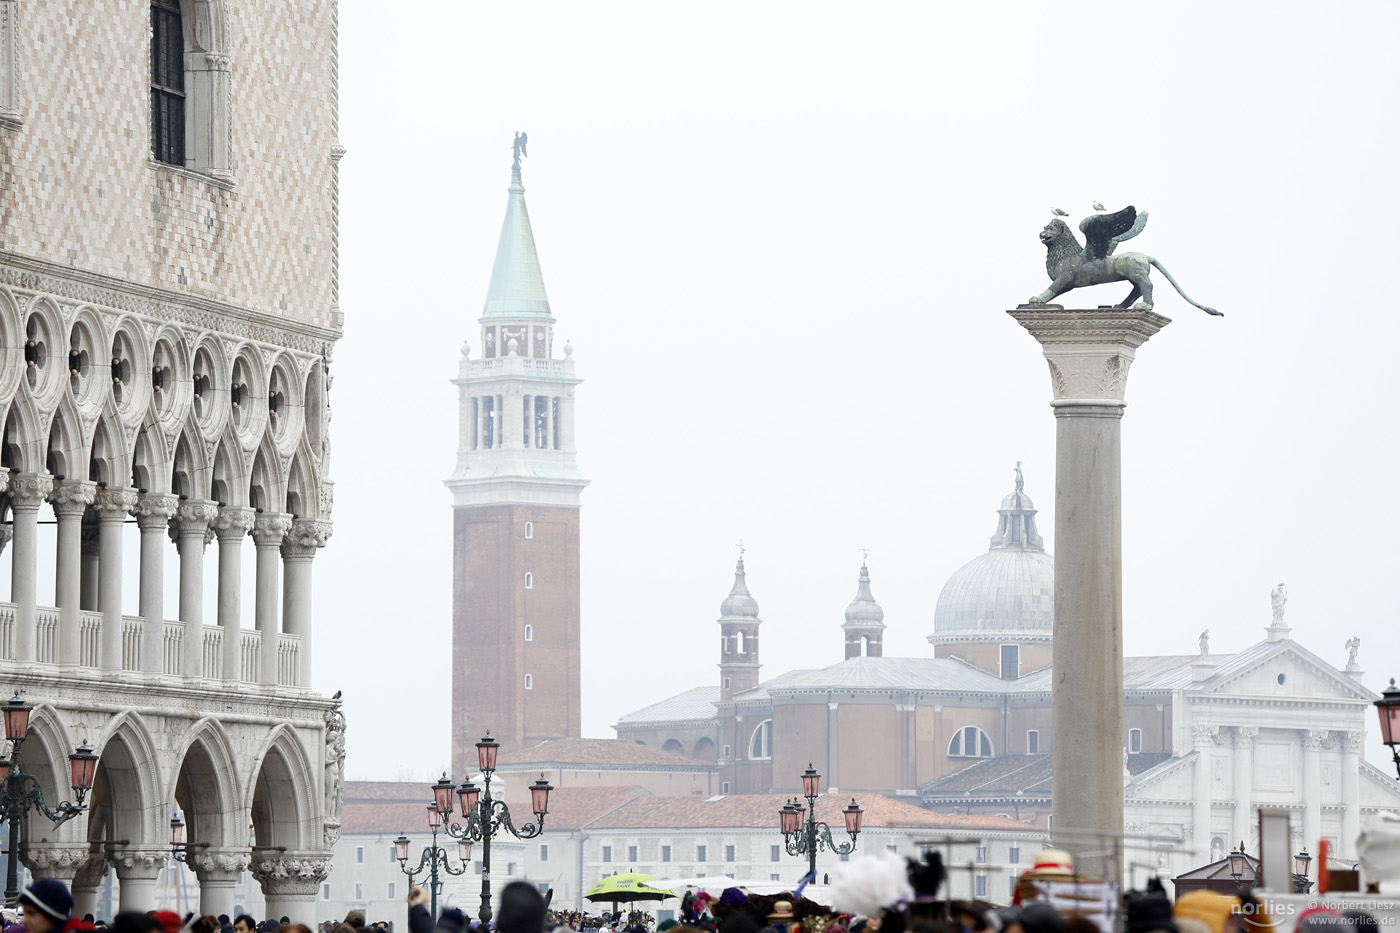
[{"x1": 1187, "y1": 640, "x2": 1376, "y2": 703}]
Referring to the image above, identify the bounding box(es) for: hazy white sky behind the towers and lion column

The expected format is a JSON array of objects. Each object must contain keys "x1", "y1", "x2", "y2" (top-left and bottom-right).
[{"x1": 315, "y1": 0, "x2": 1400, "y2": 779}]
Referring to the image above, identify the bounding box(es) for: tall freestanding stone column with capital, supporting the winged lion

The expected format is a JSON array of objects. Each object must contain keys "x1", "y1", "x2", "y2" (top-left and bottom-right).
[{"x1": 1009, "y1": 305, "x2": 1169, "y2": 881}]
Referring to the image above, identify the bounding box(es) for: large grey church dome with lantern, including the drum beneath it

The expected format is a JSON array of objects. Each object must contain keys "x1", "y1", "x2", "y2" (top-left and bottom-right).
[{"x1": 928, "y1": 464, "x2": 1054, "y2": 679}]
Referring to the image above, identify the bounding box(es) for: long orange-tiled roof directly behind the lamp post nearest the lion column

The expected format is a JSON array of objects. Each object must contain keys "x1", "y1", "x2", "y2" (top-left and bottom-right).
[{"x1": 588, "y1": 794, "x2": 1035, "y2": 832}]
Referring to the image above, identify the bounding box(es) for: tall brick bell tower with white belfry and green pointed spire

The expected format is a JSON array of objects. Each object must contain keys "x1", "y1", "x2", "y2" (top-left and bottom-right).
[{"x1": 447, "y1": 143, "x2": 588, "y2": 773}]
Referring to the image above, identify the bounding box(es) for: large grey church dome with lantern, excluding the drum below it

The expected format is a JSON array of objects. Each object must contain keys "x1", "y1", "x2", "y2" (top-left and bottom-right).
[{"x1": 928, "y1": 465, "x2": 1054, "y2": 644}]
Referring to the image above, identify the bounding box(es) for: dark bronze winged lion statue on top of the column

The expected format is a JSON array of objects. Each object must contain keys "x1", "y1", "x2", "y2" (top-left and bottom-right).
[{"x1": 1030, "y1": 205, "x2": 1224, "y2": 317}]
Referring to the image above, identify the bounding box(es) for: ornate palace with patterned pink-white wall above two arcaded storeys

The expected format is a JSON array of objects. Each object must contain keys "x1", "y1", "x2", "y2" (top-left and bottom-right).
[{"x1": 0, "y1": 0, "x2": 344, "y2": 919}]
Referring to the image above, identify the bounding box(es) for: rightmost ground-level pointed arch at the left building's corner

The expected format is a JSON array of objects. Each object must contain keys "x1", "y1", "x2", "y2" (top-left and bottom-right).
[{"x1": 244, "y1": 724, "x2": 322, "y2": 850}]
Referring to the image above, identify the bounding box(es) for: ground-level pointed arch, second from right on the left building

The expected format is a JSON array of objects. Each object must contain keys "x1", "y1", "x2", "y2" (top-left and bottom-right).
[{"x1": 168, "y1": 716, "x2": 248, "y2": 846}]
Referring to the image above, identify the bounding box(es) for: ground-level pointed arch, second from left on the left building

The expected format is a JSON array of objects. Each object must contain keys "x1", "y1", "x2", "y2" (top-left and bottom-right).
[{"x1": 88, "y1": 710, "x2": 169, "y2": 846}]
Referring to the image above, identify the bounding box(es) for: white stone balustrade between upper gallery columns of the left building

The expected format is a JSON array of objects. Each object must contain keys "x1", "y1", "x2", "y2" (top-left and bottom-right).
[{"x1": 0, "y1": 602, "x2": 301, "y2": 686}]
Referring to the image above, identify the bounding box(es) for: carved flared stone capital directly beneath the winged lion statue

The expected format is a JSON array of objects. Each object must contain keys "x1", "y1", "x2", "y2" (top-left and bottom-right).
[{"x1": 1009, "y1": 308, "x2": 1170, "y2": 403}]
